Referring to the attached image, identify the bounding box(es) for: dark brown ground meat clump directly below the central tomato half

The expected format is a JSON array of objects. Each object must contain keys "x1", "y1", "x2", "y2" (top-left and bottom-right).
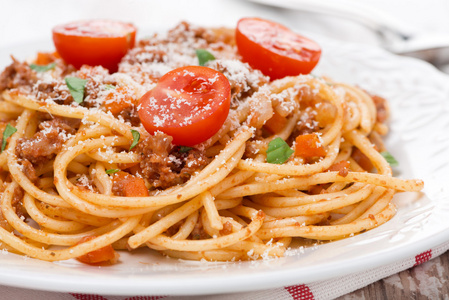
[{"x1": 136, "y1": 132, "x2": 208, "y2": 189}]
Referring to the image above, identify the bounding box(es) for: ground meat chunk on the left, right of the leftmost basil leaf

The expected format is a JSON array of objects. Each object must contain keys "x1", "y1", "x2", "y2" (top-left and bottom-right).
[{"x1": 16, "y1": 118, "x2": 77, "y2": 164}]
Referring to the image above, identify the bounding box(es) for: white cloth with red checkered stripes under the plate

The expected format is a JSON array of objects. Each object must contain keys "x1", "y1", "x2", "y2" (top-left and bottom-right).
[{"x1": 0, "y1": 242, "x2": 449, "y2": 300}]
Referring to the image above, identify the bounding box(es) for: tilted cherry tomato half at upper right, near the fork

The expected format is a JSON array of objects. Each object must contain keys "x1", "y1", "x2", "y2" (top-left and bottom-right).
[{"x1": 235, "y1": 18, "x2": 321, "y2": 80}]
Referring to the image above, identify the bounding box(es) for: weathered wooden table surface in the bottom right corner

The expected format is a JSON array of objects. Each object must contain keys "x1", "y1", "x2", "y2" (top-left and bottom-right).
[{"x1": 338, "y1": 251, "x2": 449, "y2": 300}]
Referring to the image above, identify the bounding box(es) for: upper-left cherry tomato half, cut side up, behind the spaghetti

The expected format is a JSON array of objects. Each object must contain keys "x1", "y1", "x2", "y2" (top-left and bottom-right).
[{"x1": 53, "y1": 20, "x2": 136, "y2": 72}]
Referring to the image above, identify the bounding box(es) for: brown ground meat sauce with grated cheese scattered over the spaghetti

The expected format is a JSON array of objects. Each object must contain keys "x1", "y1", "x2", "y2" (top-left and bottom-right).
[{"x1": 0, "y1": 22, "x2": 387, "y2": 195}]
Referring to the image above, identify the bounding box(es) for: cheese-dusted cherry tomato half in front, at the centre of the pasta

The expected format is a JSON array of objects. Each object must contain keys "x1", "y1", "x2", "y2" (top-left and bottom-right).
[{"x1": 139, "y1": 66, "x2": 231, "y2": 146}]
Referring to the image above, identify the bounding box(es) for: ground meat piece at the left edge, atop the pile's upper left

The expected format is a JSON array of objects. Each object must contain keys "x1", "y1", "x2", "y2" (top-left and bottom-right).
[{"x1": 0, "y1": 58, "x2": 37, "y2": 91}]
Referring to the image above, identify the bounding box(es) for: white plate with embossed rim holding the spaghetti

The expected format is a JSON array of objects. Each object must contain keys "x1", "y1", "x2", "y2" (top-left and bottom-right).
[{"x1": 0, "y1": 22, "x2": 449, "y2": 295}]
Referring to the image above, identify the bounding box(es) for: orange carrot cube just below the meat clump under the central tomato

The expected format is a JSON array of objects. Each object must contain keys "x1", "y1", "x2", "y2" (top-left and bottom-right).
[{"x1": 112, "y1": 171, "x2": 149, "y2": 197}]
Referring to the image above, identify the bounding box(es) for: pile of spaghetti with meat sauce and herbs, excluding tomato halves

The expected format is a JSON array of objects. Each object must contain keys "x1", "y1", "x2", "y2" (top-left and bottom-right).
[{"x1": 0, "y1": 18, "x2": 423, "y2": 264}]
